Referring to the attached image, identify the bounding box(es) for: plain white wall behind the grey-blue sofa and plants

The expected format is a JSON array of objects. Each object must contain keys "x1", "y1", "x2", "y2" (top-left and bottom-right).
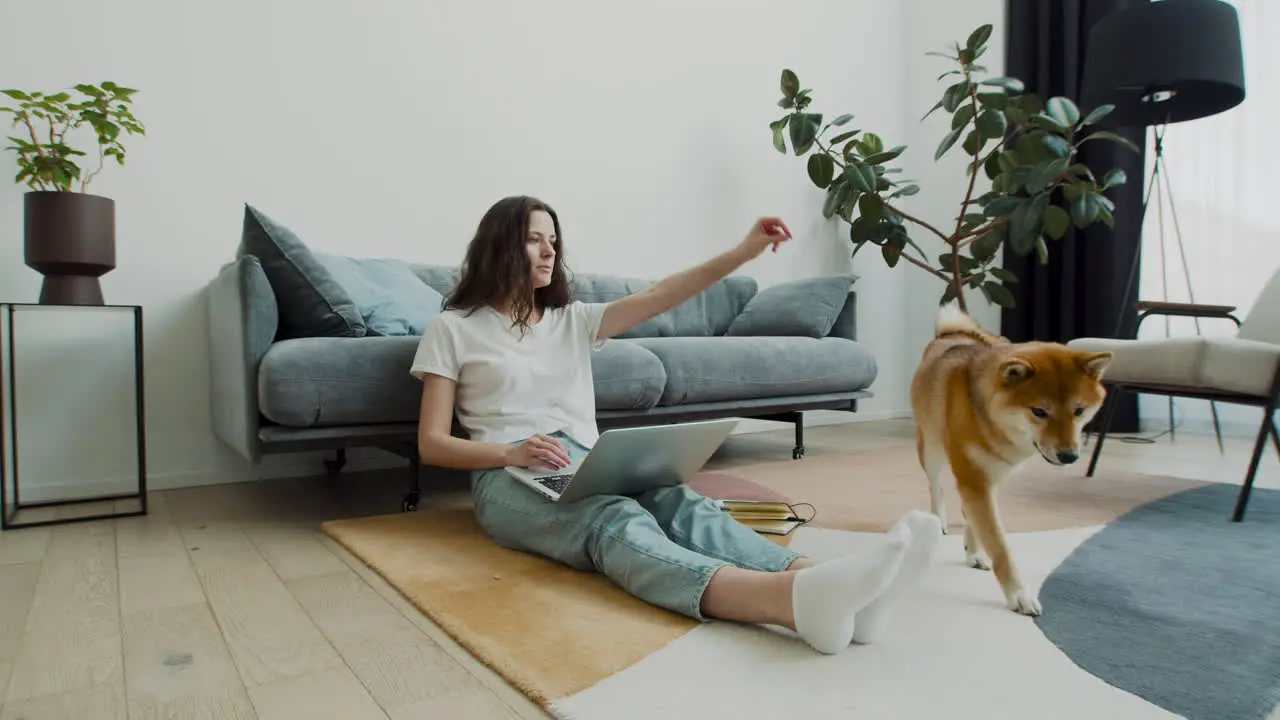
[{"x1": 0, "y1": 0, "x2": 1001, "y2": 489}]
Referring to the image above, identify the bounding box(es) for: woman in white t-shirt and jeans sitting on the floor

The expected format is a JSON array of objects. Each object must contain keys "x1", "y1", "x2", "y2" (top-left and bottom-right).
[{"x1": 411, "y1": 197, "x2": 941, "y2": 653}]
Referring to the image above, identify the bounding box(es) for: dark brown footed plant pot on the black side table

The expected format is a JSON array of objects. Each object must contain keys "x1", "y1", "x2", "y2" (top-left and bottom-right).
[{"x1": 23, "y1": 191, "x2": 115, "y2": 305}]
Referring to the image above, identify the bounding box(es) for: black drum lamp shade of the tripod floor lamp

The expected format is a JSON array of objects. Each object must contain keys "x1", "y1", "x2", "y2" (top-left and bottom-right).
[{"x1": 1080, "y1": 0, "x2": 1244, "y2": 127}]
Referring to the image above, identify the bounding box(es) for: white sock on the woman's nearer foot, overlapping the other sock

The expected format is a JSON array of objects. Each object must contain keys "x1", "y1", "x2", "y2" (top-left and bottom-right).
[{"x1": 791, "y1": 525, "x2": 910, "y2": 655}]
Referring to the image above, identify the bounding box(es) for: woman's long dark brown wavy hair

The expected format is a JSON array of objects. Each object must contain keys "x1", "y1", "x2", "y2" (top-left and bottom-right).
[{"x1": 444, "y1": 195, "x2": 570, "y2": 329}]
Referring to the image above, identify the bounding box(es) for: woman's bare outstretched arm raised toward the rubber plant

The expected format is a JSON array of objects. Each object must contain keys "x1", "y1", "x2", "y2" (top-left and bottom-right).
[{"x1": 596, "y1": 218, "x2": 791, "y2": 340}]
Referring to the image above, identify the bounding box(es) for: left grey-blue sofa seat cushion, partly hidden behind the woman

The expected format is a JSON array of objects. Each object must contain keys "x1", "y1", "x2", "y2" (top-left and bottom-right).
[{"x1": 257, "y1": 336, "x2": 667, "y2": 428}]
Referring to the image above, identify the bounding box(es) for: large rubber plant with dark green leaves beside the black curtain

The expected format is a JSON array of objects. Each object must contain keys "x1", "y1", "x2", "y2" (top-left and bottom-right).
[{"x1": 769, "y1": 24, "x2": 1139, "y2": 310}]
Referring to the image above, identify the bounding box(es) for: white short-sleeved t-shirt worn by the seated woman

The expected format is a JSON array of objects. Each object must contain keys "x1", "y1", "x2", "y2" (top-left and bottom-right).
[{"x1": 410, "y1": 301, "x2": 607, "y2": 447}]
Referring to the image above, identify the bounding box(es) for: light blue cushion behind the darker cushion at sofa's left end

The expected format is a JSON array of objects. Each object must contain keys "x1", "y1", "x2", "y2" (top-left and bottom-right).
[{"x1": 315, "y1": 252, "x2": 444, "y2": 336}]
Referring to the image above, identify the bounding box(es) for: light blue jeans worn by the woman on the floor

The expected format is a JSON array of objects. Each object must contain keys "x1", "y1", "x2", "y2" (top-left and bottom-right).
[{"x1": 471, "y1": 433, "x2": 799, "y2": 620}]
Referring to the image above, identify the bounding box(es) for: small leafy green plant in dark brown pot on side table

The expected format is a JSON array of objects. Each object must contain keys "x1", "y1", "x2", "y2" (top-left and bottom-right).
[{"x1": 0, "y1": 82, "x2": 146, "y2": 305}]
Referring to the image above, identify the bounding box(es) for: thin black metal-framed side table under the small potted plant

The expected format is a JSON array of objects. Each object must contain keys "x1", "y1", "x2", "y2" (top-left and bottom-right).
[{"x1": 0, "y1": 302, "x2": 147, "y2": 530}]
